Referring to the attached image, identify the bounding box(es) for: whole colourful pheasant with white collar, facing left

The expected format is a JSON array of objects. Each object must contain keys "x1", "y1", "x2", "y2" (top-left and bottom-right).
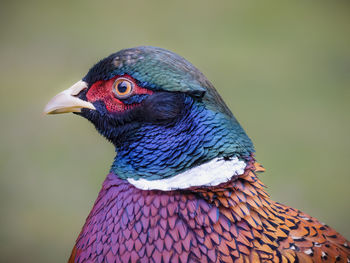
[{"x1": 44, "y1": 46, "x2": 350, "y2": 263}]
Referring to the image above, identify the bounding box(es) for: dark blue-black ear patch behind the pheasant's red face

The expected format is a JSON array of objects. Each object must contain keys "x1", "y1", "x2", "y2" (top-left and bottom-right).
[{"x1": 141, "y1": 92, "x2": 186, "y2": 122}]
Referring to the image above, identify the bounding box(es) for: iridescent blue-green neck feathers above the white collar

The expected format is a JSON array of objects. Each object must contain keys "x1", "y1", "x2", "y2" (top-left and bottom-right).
[{"x1": 111, "y1": 103, "x2": 254, "y2": 183}]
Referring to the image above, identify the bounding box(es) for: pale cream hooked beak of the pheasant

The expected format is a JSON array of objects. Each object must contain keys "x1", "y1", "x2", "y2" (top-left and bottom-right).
[{"x1": 44, "y1": 80, "x2": 96, "y2": 114}]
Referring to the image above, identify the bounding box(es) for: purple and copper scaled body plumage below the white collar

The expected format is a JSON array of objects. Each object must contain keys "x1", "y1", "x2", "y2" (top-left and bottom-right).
[{"x1": 69, "y1": 160, "x2": 350, "y2": 263}]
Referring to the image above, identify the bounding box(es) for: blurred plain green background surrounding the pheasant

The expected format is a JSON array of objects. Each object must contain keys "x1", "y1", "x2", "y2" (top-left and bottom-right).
[{"x1": 0, "y1": 0, "x2": 350, "y2": 262}]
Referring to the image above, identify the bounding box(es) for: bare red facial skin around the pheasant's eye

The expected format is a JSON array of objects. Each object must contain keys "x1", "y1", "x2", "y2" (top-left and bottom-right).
[{"x1": 86, "y1": 75, "x2": 153, "y2": 113}]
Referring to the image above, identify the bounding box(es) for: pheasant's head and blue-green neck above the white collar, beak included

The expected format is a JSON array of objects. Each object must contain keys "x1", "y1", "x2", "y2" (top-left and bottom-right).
[{"x1": 44, "y1": 47, "x2": 254, "y2": 187}]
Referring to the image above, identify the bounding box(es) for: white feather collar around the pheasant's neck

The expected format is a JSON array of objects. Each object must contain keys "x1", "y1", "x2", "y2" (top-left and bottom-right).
[{"x1": 127, "y1": 157, "x2": 246, "y2": 191}]
